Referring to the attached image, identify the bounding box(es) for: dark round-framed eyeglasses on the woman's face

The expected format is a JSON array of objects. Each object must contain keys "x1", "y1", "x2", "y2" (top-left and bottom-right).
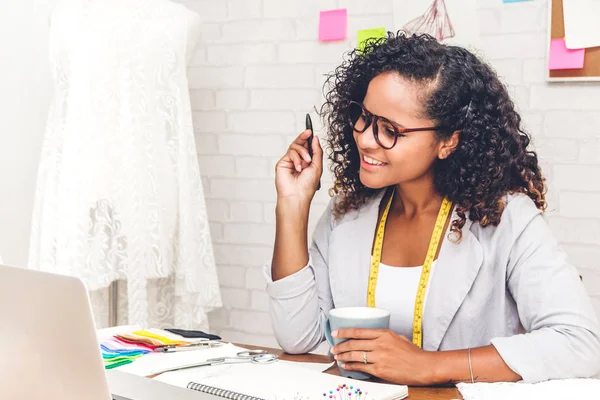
[{"x1": 349, "y1": 101, "x2": 442, "y2": 150}]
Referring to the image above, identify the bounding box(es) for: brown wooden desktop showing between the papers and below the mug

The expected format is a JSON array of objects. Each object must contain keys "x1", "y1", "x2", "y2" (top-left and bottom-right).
[{"x1": 236, "y1": 344, "x2": 462, "y2": 400}]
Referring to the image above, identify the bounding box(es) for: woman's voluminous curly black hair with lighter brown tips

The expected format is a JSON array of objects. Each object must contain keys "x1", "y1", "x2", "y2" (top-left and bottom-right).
[{"x1": 320, "y1": 31, "x2": 546, "y2": 240}]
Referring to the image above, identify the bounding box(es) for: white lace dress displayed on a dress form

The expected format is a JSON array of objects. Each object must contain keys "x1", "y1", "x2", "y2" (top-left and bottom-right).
[{"x1": 29, "y1": 0, "x2": 221, "y2": 329}]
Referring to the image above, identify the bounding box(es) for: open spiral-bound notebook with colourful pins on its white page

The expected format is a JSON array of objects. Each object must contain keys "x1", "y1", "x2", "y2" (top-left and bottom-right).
[{"x1": 154, "y1": 362, "x2": 408, "y2": 400}]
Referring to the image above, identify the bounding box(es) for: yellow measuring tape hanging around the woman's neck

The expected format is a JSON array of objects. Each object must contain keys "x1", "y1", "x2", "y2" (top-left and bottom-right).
[{"x1": 367, "y1": 192, "x2": 452, "y2": 347}]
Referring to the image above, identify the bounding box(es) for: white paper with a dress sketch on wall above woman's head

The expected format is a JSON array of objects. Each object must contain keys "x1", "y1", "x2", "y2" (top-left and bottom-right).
[{"x1": 394, "y1": 0, "x2": 480, "y2": 52}]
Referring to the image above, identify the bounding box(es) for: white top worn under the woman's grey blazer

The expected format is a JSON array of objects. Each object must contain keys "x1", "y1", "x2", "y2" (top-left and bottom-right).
[{"x1": 375, "y1": 260, "x2": 437, "y2": 340}]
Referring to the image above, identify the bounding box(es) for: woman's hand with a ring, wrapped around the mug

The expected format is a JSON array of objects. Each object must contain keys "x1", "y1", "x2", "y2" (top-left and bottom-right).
[{"x1": 331, "y1": 328, "x2": 434, "y2": 386}]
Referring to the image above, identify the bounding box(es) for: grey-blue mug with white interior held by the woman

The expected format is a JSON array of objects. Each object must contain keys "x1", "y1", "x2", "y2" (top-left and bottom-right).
[{"x1": 325, "y1": 307, "x2": 390, "y2": 379}]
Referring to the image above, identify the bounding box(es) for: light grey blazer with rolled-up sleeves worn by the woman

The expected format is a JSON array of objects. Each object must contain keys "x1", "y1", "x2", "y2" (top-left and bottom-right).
[{"x1": 265, "y1": 191, "x2": 600, "y2": 382}]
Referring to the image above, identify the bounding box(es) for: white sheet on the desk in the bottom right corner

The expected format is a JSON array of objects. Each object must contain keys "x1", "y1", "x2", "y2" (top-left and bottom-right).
[{"x1": 456, "y1": 379, "x2": 600, "y2": 400}]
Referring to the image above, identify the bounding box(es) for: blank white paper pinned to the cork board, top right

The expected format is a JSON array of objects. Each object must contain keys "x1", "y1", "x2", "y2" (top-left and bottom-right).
[{"x1": 563, "y1": 0, "x2": 600, "y2": 49}]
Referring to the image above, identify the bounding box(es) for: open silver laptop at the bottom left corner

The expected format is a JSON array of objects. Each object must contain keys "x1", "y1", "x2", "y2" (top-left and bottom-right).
[{"x1": 0, "y1": 265, "x2": 219, "y2": 400}]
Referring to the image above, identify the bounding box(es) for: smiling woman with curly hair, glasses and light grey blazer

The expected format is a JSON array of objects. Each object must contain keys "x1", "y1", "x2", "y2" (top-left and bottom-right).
[{"x1": 266, "y1": 33, "x2": 600, "y2": 385}]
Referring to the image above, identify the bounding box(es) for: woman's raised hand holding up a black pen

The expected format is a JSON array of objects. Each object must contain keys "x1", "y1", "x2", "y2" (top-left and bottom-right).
[{"x1": 275, "y1": 129, "x2": 323, "y2": 203}]
